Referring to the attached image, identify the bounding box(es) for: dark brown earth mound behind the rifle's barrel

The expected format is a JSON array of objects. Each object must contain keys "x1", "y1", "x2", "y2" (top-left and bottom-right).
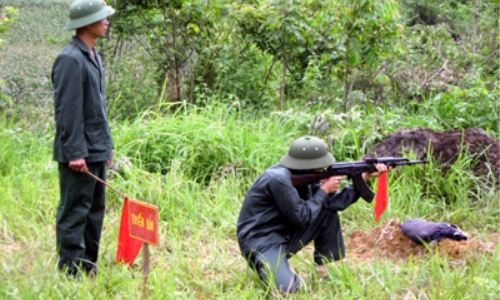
[{"x1": 365, "y1": 128, "x2": 500, "y2": 184}]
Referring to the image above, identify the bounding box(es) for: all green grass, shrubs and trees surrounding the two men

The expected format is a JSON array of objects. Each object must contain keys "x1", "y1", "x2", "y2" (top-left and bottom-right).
[{"x1": 0, "y1": 0, "x2": 500, "y2": 299}]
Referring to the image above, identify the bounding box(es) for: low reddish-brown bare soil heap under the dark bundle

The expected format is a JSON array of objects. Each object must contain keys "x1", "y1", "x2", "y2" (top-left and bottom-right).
[{"x1": 346, "y1": 220, "x2": 500, "y2": 262}]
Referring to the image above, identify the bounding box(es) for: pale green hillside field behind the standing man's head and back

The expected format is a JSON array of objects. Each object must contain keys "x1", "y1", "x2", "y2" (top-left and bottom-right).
[{"x1": 0, "y1": 0, "x2": 74, "y2": 126}]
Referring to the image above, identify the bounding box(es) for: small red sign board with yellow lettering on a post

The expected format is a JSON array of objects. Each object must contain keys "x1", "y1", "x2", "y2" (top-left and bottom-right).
[{"x1": 129, "y1": 199, "x2": 159, "y2": 246}]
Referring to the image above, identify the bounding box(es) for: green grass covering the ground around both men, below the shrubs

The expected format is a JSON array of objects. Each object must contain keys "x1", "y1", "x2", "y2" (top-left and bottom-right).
[{"x1": 0, "y1": 104, "x2": 500, "y2": 299}]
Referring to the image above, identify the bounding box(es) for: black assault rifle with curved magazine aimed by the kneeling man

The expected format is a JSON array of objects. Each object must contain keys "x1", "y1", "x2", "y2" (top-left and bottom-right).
[{"x1": 292, "y1": 157, "x2": 429, "y2": 203}]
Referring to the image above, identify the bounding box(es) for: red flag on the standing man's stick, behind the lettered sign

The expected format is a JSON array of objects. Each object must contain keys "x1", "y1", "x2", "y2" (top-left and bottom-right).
[{"x1": 116, "y1": 197, "x2": 142, "y2": 266}]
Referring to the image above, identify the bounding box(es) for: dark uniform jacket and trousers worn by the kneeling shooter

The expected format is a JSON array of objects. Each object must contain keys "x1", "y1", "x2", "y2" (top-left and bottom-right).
[{"x1": 237, "y1": 164, "x2": 359, "y2": 292}]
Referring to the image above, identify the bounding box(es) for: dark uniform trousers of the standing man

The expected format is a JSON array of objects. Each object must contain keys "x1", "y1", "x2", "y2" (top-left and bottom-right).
[{"x1": 56, "y1": 162, "x2": 106, "y2": 274}]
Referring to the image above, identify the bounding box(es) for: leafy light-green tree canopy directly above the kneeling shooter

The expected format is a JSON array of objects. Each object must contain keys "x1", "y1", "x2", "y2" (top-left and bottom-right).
[{"x1": 235, "y1": 0, "x2": 402, "y2": 110}]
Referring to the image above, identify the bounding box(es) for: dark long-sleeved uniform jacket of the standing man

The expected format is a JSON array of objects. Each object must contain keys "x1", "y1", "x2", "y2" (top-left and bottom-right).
[{"x1": 51, "y1": 36, "x2": 113, "y2": 163}]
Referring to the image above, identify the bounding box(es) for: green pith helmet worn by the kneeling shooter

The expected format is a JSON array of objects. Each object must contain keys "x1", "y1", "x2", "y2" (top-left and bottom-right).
[{"x1": 280, "y1": 136, "x2": 335, "y2": 170}]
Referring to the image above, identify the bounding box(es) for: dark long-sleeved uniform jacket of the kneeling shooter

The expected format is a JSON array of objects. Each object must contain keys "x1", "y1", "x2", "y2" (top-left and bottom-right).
[{"x1": 237, "y1": 164, "x2": 360, "y2": 256}]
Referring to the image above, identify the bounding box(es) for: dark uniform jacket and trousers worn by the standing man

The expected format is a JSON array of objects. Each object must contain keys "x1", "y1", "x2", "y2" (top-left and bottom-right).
[{"x1": 52, "y1": 36, "x2": 113, "y2": 273}]
